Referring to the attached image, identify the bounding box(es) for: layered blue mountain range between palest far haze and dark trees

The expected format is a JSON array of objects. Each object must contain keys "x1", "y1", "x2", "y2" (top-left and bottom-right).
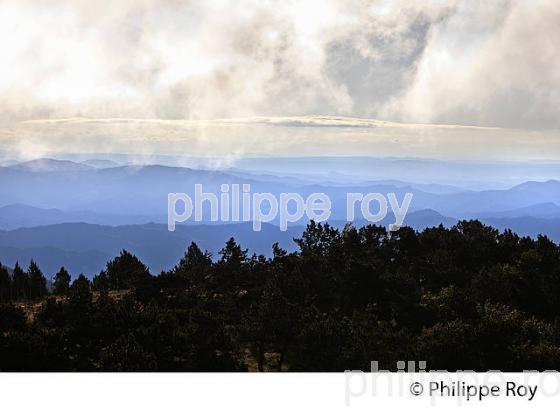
[{"x1": 0, "y1": 158, "x2": 560, "y2": 277}]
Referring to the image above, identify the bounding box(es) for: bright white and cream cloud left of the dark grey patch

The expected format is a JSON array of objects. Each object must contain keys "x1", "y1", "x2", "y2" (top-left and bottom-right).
[{"x1": 0, "y1": 0, "x2": 351, "y2": 120}]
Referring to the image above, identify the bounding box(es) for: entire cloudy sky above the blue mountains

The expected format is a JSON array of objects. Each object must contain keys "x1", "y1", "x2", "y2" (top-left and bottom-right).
[{"x1": 0, "y1": 0, "x2": 560, "y2": 160}]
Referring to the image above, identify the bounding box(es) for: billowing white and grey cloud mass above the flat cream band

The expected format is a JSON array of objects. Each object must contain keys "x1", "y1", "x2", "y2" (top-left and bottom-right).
[{"x1": 0, "y1": 0, "x2": 560, "y2": 138}]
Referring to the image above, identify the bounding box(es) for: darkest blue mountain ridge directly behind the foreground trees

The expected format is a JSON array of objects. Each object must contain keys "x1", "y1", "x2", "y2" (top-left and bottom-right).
[{"x1": 0, "y1": 210, "x2": 560, "y2": 277}]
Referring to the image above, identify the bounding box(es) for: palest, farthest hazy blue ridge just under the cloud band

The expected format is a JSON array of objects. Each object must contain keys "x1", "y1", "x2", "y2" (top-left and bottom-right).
[{"x1": 5, "y1": 156, "x2": 560, "y2": 190}]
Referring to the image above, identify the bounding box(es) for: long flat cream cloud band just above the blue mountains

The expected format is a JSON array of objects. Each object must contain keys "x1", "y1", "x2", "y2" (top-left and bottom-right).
[{"x1": 5, "y1": 116, "x2": 560, "y2": 165}]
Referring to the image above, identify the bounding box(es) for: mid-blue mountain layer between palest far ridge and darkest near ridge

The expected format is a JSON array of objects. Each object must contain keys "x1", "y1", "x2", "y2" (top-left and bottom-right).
[{"x1": 0, "y1": 161, "x2": 560, "y2": 222}]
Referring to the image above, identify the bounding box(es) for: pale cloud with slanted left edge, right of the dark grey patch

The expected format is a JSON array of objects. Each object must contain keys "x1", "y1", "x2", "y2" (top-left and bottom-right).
[{"x1": 380, "y1": 0, "x2": 560, "y2": 129}]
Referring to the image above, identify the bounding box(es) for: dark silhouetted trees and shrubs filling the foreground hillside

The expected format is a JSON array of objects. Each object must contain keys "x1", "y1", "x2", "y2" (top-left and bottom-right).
[{"x1": 0, "y1": 221, "x2": 560, "y2": 371}]
